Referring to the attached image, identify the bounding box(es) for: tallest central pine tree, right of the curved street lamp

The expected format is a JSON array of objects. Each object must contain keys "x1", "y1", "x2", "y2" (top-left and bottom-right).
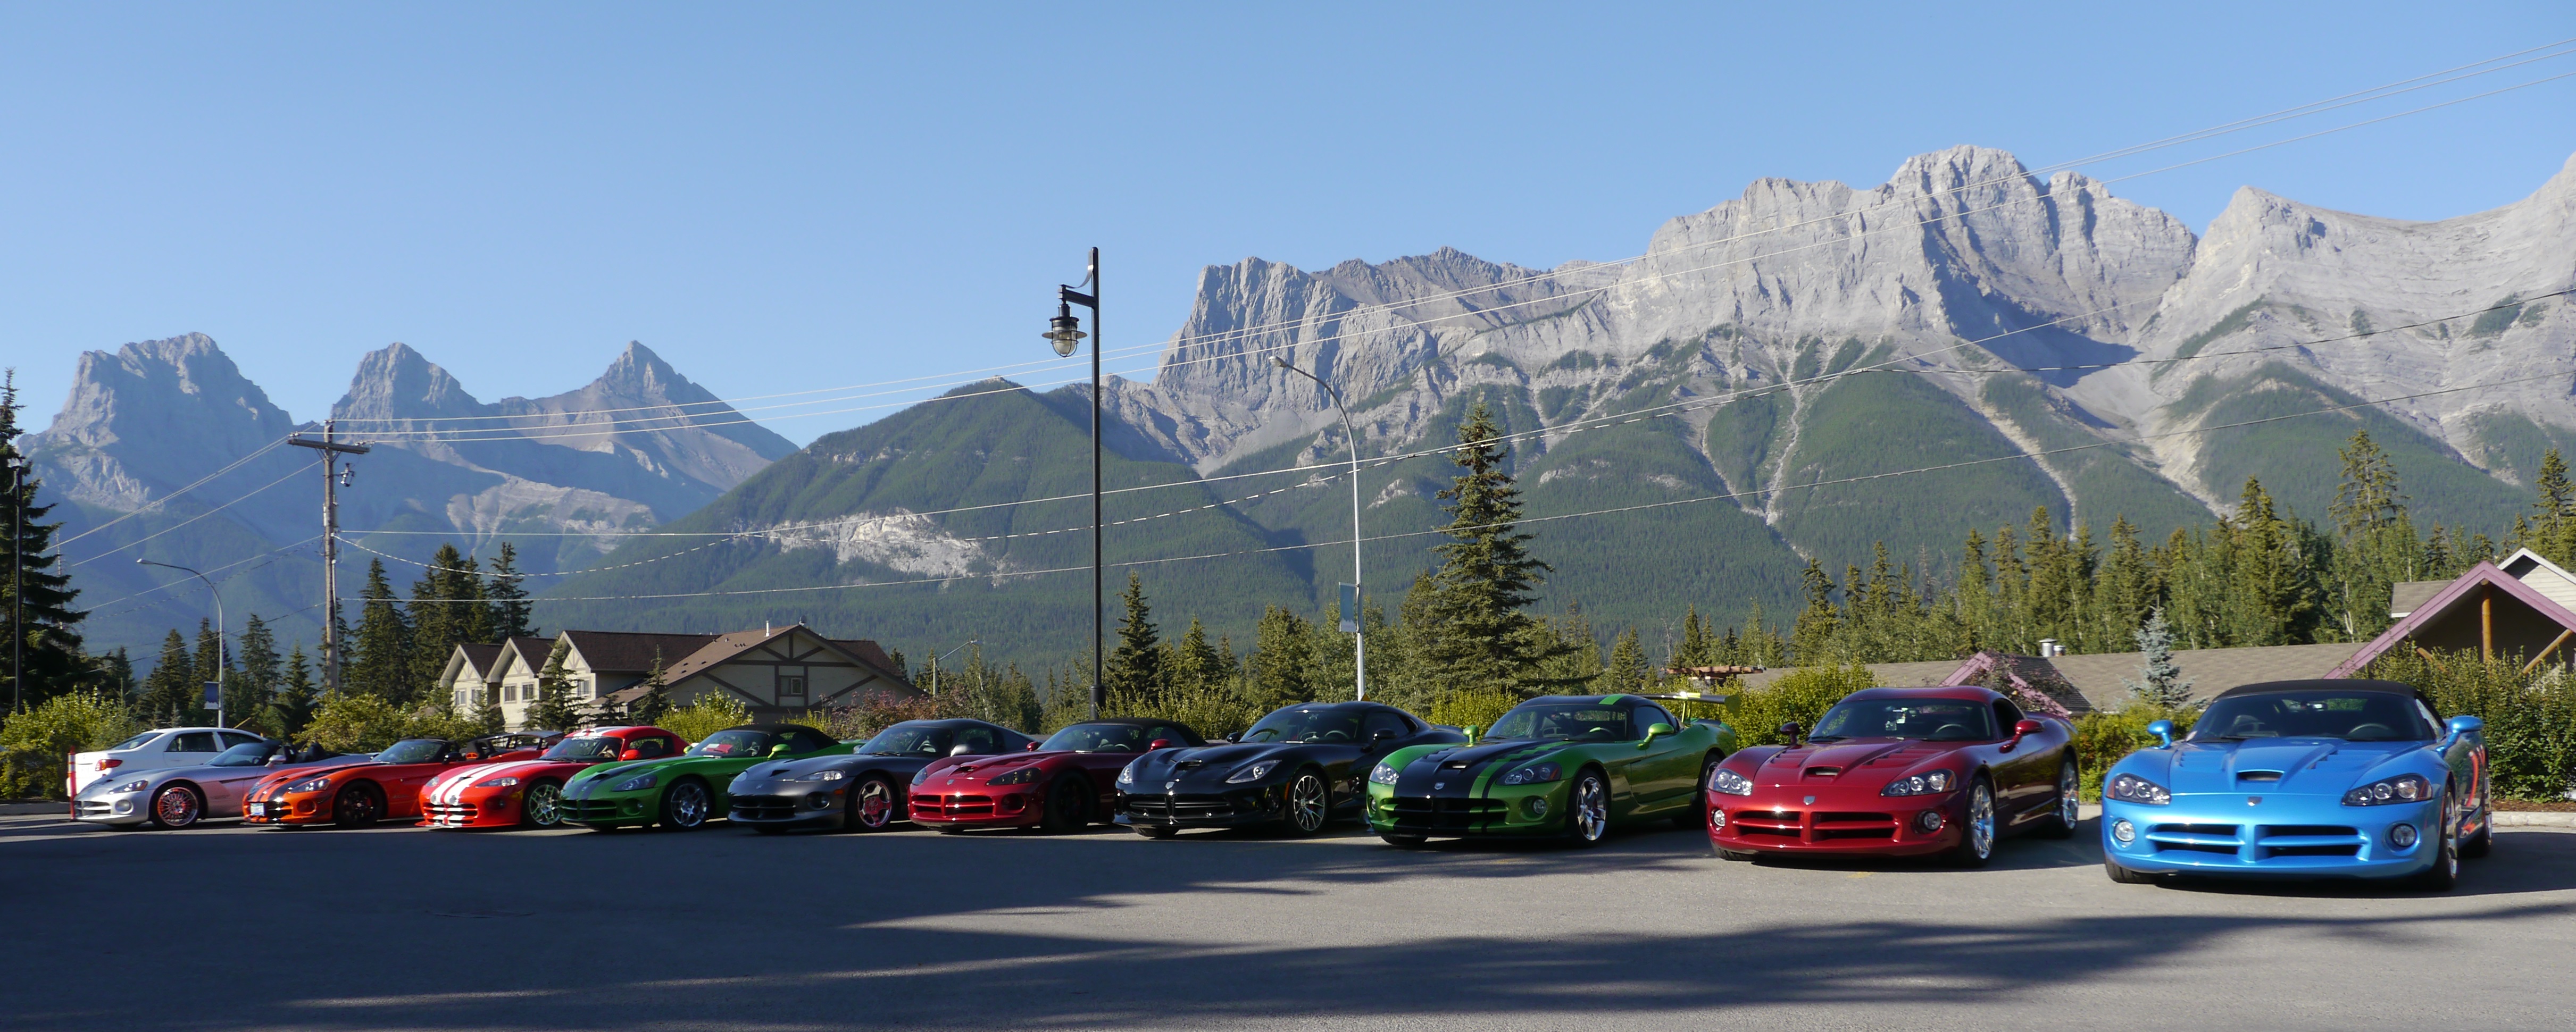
[{"x1": 1419, "y1": 401, "x2": 1564, "y2": 692}]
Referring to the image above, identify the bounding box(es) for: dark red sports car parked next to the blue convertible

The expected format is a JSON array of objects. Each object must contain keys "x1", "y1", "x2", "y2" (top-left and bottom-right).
[{"x1": 1703, "y1": 685, "x2": 2076, "y2": 867}]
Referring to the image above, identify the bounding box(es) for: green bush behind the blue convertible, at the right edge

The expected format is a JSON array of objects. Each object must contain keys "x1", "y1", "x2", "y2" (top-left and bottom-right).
[{"x1": 2365, "y1": 651, "x2": 2576, "y2": 800}]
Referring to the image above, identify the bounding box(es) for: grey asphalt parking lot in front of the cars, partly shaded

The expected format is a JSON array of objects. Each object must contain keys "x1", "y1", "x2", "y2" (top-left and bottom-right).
[{"x1": 0, "y1": 818, "x2": 2576, "y2": 1029}]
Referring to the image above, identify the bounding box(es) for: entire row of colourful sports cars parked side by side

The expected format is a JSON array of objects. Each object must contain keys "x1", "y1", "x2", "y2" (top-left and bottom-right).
[{"x1": 74, "y1": 679, "x2": 2494, "y2": 888}]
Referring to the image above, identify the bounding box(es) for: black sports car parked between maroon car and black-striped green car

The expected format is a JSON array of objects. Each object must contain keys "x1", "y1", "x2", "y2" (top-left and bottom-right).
[{"x1": 1118, "y1": 702, "x2": 1466, "y2": 839}]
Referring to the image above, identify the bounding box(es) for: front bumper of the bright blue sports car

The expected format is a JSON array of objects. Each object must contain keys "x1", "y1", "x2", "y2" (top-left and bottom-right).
[{"x1": 2102, "y1": 793, "x2": 2442, "y2": 878}]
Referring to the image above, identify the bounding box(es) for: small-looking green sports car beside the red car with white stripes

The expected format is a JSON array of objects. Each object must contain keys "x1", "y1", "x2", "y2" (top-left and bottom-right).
[{"x1": 564, "y1": 723, "x2": 858, "y2": 831}]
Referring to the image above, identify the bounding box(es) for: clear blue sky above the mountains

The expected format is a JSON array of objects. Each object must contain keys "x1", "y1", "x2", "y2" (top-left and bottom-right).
[{"x1": 0, "y1": 0, "x2": 2576, "y2": 443}]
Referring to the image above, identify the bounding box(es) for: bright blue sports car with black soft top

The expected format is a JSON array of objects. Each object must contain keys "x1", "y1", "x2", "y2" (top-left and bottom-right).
[{"x1": 2102, "y1": 679, "x2": 2494, "y2": 891}]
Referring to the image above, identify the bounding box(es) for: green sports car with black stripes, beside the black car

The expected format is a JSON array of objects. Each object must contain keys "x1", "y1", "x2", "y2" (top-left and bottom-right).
[{"x1": 1368, "y1": 695, "x2": 1736, "y2": 846}]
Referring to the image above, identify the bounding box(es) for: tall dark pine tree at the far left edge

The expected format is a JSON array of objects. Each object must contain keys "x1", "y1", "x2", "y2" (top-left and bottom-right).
[{"x1": 0, "y1": 371, "x2": 90, "y2": 708}]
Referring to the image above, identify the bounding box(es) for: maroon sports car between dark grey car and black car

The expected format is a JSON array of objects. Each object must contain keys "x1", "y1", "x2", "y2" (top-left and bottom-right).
[{"x1": 910, "y1": 720, "x2": 1208, "y2": 834}]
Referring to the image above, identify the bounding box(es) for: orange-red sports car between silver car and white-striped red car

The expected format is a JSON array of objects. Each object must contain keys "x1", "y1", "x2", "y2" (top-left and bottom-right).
[{"x1": 242, "y1": 734, "x2": 562, "y2": 829}]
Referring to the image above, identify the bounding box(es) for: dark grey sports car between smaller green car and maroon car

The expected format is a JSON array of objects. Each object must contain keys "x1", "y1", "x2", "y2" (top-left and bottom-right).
[{"x1": 727, "y1": 720, "x2": 1036, "y2": 834}]
